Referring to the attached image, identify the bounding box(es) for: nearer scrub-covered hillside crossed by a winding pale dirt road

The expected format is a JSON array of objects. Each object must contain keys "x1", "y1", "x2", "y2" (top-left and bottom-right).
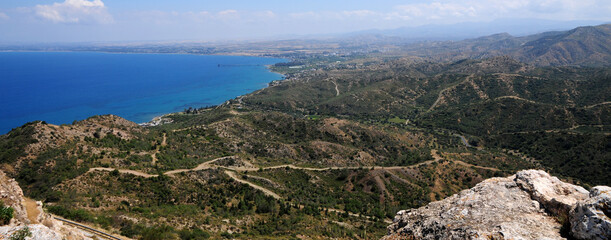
[{"x1": 2, "y1": 109, "x2": 533, "y2": 239}]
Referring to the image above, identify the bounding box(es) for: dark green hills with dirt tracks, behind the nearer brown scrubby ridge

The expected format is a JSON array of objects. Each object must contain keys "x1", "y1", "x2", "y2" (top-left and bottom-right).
[{"x1": 247, "y1": 57, "x2": 611, "y2": 184}]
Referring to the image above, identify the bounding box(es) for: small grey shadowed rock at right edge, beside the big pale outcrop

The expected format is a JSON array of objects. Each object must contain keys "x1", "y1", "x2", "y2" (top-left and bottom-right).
[{"x1": 570, "y1": 186, "x2": 611, "y2": 239}]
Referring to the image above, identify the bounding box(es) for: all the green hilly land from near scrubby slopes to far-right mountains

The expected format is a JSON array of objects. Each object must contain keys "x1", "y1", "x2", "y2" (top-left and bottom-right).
[{"x1": 0, "y1": 25, "x2": 611, "y2": 239}]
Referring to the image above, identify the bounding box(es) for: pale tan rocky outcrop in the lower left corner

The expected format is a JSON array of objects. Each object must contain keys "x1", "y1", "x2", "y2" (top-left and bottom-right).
[{"x1": 0, "y1": 171, "x2": 92, "y2": 240}]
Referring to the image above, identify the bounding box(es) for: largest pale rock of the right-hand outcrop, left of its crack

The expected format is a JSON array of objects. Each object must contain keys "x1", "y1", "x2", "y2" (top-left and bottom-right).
[{"x1": 385, "y1": 172, "x2": 562, "y2": 239}]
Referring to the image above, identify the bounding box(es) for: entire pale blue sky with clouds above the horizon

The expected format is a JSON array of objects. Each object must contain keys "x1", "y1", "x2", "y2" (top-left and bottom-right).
[{"x1": 0, "y1": 0, "x2": 611, "y2": 43}]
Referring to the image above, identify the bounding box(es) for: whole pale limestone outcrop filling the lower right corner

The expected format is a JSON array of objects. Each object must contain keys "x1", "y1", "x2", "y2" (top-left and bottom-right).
[{"x1": 383, "y1": 170, "x2": 611, "y2": 239}]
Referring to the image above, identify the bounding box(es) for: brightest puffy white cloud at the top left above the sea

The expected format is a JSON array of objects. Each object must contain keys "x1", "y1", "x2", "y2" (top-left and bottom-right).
[{"x1": 34, "y1": 0, "x2": 114, "y2": 23}]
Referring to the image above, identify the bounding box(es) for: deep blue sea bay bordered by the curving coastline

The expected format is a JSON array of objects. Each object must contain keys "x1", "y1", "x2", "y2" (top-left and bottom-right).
[{"x1": 0, "y1": 52, "x2": 285, "y2": 134}]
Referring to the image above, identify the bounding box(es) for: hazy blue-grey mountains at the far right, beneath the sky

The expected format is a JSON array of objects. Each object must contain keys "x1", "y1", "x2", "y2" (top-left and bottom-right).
[{"x1": 404, "y1": 24, "x2": 611, "y2": 66}]
